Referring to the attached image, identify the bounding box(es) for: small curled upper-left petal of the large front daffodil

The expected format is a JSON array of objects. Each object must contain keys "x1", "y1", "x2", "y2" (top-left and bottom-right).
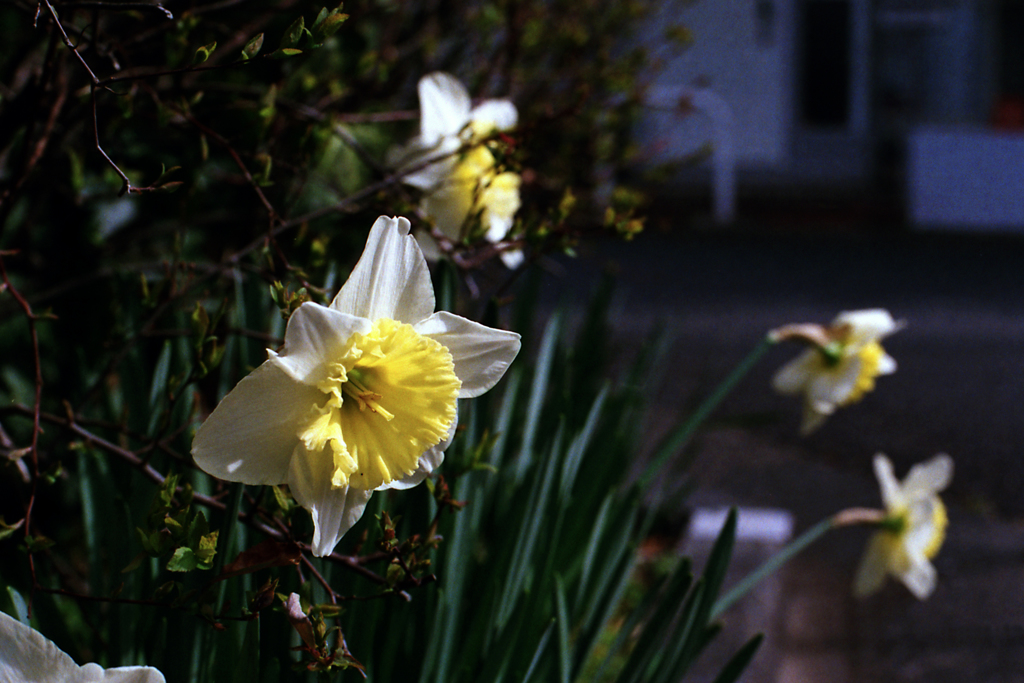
[{"x1": 268, "y1": 301, "x2": 373, "y2": 386}]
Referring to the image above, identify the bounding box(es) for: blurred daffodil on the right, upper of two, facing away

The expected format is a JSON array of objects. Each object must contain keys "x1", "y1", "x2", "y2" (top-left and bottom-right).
[{"x1": 772, "y1": 308, "x2": 902, "y2": 434}]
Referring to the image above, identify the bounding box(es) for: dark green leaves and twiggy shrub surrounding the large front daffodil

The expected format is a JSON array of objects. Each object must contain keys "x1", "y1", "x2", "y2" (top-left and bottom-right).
[{"x1": 0, "y1": 0, "x2": 765, "y2": 683}]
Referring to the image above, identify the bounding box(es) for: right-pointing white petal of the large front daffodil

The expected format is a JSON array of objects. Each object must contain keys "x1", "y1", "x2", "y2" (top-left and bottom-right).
[{"x1": 413, "y1": 310, "x2": 520, "y2": 398}]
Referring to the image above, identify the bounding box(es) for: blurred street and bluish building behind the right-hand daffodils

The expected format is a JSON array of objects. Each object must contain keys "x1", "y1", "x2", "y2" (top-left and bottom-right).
[{"x1": 551, "y1": 0, "x2": 1024, "y2": 683}]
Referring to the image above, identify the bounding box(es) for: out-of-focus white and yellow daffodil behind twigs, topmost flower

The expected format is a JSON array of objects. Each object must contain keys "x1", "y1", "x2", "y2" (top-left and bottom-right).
[{"x1": 389, "y1": 72, "x2": 522, "y2": 268}]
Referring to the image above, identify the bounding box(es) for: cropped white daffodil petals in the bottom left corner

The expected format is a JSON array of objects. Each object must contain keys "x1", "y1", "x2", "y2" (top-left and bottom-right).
[{"x1": 0, "y1": 612, "x2": 165, "y2": 683}]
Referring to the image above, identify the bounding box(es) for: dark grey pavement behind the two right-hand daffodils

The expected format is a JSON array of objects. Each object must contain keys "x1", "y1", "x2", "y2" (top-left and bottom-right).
[{"x1": 536, "y1": 225, "x2": 1024, "y2": 683}]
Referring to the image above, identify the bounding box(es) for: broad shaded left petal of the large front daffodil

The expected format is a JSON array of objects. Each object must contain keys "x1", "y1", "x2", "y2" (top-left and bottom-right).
[{"x1": 191, "y1": 360, "x2": 323, "y2": 484}]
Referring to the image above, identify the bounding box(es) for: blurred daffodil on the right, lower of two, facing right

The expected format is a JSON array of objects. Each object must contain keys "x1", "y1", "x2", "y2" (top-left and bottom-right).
[{"x1": 853, "y1": 454, "x2": 953, "y2": 600}]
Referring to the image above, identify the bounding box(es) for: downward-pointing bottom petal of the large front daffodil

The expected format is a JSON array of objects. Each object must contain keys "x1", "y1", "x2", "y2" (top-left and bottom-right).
[{"x1": 288, "y1": 446, "x2": 373, "y2": 557}]
